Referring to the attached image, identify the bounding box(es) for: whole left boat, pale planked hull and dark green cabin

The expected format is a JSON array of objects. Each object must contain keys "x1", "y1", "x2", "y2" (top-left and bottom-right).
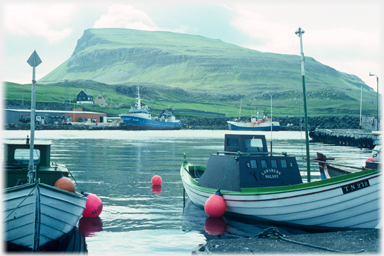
[{"x1": 3, "y1": 140, "x2": 87, "y2": 251}]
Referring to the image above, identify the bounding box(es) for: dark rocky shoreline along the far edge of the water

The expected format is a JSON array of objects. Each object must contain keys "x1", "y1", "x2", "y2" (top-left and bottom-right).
[{"x1": 4, "y1": 116, "x2": 359, "y2": 131}]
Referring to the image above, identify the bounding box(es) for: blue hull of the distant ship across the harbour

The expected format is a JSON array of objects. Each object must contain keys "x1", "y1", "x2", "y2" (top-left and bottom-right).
[{"x1": 120, "y1": 114, "x2": 181, "y2": 130}]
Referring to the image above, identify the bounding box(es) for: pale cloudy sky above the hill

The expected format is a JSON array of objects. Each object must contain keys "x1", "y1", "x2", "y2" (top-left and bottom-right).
[{"x1": 1, "y1": 0, "x2": 384, "y2": 92}]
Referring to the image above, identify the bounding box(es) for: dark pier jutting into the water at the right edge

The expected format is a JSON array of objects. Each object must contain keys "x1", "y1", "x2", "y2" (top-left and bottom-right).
[{"x1": 309, "y1": 129, "x2": 381, "y2": 149}]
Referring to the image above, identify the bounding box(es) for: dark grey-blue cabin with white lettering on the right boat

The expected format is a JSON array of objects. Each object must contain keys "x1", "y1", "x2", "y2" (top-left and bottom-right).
[{"x1": 198, "y1": 134, "x2": 302, "y2": 191}]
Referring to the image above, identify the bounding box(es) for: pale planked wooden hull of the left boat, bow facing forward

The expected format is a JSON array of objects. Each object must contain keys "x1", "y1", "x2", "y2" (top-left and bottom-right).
[{"x1": 3, "y1": 182, "x2": 87, "y2": 251}]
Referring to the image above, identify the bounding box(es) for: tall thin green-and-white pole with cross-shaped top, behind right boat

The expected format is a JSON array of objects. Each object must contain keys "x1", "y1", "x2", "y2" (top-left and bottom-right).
[{"x1": 295, "y1": 27, "x2": 311, "y2": 182}]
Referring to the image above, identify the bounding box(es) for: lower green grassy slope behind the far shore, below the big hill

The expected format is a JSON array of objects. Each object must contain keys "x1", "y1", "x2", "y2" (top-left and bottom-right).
[{"x1": 4, "y1": 81, "x2": 376, "y2": 117}]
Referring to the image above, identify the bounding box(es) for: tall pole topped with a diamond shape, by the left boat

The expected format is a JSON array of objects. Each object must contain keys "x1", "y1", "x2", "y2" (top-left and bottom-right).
[{"x1": 27, "y1": 51, "x2": 42, "y2": 183}]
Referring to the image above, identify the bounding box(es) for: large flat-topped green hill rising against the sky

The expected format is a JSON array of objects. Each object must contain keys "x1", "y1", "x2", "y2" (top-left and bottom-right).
[{"x1": 30, "y1": 29, "x2": 376, "y2": 115}]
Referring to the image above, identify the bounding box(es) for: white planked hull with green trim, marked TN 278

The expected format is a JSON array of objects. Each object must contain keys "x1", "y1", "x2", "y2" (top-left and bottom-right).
[{"x1": 180, "y1": 166, "x2": 380, "y2": 228}]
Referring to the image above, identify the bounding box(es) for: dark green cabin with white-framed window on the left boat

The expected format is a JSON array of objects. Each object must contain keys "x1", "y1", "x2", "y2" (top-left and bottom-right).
[{"x1": 3, "y1": 139, "x2": 68, "y2": 187}]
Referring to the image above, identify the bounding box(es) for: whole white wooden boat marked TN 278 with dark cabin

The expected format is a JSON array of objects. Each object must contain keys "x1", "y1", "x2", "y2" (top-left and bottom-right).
[{"x1": 180, "y1": 134, "x2": 381, "y2": 229}]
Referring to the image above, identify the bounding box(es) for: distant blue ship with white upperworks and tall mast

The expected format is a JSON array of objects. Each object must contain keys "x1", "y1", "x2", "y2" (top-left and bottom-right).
[{"x1": 119, "y1": 87, "x2": 181, "y2": 130}]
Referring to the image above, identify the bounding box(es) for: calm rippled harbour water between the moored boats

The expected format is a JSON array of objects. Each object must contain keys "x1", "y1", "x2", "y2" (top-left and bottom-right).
[{"x1": 3, "y1": 130, "x2": 371, "y2": 255}]
